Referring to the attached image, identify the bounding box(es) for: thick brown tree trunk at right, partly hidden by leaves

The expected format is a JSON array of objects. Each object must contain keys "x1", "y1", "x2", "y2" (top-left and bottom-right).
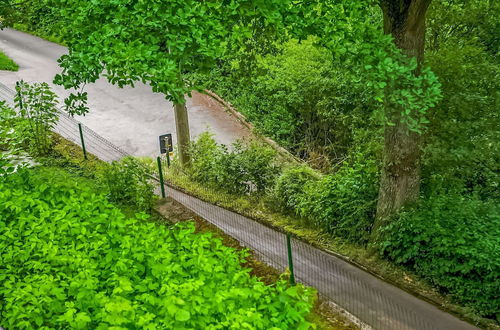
[{"x1": 372, "y1": 0, "x2": 431, "y2": 236}]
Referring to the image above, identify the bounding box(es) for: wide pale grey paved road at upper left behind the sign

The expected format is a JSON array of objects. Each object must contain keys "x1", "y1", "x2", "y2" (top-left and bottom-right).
[{"x1": 0, "y1": 29, "x2": 250, "y2": 156}]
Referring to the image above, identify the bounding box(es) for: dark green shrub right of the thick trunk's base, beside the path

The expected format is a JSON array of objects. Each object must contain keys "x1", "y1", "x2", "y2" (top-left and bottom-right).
[{"x1": 380, "y1": 192, "x2": 500, "y2": 317}]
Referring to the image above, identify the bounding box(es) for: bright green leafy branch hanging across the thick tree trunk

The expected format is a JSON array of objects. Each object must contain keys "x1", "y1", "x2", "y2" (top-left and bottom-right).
[{"x1": 299, "y1": 0, "x2": 441, "y2": 133}]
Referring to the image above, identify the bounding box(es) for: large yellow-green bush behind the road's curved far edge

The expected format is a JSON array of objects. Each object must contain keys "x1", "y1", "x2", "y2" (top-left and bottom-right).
[{"x1": 198, "y1": 40, "x2": 372, "y2": 167}]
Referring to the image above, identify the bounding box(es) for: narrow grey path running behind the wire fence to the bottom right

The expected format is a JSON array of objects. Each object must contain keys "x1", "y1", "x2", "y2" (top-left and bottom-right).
[{"x1": 167, "y1": 187, "x2": 475, "y2": 330}]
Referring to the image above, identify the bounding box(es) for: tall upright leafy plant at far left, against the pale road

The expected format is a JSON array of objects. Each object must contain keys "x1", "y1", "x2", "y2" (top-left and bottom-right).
[{"x1": 13, "y1": 81, "x2": 59, "y2": 155}]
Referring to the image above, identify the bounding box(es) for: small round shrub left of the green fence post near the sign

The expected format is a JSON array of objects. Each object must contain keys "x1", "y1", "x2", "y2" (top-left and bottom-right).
[{"x1": 98, "y1": 157, "x2": 155, "y2": 211}]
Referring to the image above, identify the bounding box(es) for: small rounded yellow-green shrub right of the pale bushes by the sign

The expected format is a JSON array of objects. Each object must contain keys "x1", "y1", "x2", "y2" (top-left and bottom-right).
[{"x1": 274, "y1": 165, "x2": 320, "y2": 213}]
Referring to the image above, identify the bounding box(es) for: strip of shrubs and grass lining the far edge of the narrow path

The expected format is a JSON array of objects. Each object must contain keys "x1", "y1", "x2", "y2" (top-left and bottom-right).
[{"x1": 155, "y1": 133, "x2": 500, "y2": 326}]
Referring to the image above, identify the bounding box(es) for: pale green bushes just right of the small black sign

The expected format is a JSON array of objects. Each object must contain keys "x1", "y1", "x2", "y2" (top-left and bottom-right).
[{"x1": 187, "y1": 133, "x2": 279, "y2": 194}]
